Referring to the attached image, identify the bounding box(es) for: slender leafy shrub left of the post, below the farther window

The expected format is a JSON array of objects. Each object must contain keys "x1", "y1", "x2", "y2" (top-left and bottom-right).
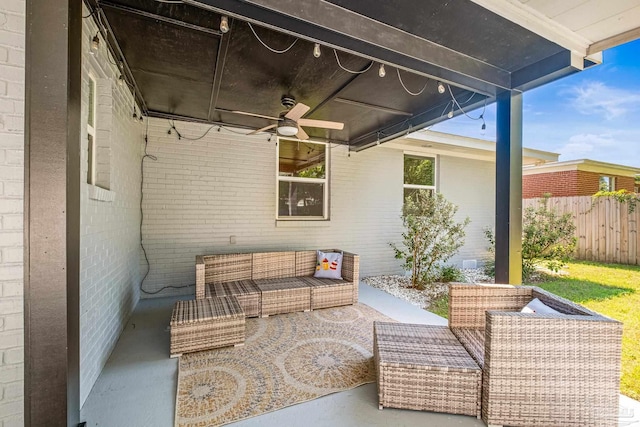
[{"x1": 390, "y1": 190, "x2": 470, "y2": 289}]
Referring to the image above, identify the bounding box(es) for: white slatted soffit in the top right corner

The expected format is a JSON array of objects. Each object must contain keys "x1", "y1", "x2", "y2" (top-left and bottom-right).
[{"x1": 471, "y1": 0, "x2": 640, "y2": 56}]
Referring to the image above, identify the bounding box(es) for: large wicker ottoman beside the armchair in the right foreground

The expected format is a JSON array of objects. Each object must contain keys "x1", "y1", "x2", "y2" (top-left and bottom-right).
[{"x1": 373, "y1": 322, "x2": 482, "y2": 418}]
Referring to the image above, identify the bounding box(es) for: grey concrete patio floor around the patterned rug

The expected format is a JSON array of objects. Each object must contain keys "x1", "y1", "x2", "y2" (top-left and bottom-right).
[{"x1": 81, "y1": 283, "x2": 640, "y2": 427}]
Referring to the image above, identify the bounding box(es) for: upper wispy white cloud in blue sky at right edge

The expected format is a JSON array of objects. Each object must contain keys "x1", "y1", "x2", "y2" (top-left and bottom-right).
[{"x1": 569, "y1": 81, "x2": 640, "y2": 120}]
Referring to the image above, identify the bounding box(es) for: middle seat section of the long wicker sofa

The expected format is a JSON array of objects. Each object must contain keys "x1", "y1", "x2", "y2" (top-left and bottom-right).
[{"x1": 255, "y1": 277, "x2": 311, "y2": 317}]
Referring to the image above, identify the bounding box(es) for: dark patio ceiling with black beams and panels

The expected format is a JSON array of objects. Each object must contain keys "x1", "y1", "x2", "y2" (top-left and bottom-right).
[{"x1": 89, "y1": 0, "x2": 593, "y2": 150}]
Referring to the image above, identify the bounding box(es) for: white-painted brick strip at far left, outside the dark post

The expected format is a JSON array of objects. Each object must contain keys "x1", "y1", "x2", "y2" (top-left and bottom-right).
[{"x1": 0, "y1": 0, "x2": 25, "y2": 426}]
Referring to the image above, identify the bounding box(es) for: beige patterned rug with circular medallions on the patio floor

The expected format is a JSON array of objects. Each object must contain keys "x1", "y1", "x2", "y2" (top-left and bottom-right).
[{"x1": 175, "y1": 303, "x2": 392, "y2": 427}]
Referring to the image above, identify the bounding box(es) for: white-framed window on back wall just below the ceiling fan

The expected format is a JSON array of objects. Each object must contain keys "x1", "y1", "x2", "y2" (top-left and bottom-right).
[{"x1": 277, "y1": 138, "x2": 328, "y2": 219}]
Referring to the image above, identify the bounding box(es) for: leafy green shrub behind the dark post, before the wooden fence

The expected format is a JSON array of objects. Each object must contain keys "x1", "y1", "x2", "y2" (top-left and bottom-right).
[{"x1": 485, "y1": 196, "x2": 577, "y2": 282}]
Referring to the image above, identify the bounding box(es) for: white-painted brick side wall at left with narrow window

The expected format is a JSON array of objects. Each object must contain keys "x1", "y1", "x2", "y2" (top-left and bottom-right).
[{"x1": 80, "y1": 9, "x2": 144, "y2": 404}]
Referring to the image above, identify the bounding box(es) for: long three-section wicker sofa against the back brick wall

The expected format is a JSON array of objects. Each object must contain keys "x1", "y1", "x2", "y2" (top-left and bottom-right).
[{"x1": 196, "y1": 249, "x2": 360, "y2": 317}]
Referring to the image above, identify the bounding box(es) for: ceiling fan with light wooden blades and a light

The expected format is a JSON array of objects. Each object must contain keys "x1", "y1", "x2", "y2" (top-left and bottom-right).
[{"x1": 233, "y1": 95, "x2": 344, "y2": 139}]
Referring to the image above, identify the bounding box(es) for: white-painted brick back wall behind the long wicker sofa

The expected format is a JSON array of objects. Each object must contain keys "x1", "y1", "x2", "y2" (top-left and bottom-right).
[{"x1": 143, "y1": 119, "x2": 494, "y2": 295}]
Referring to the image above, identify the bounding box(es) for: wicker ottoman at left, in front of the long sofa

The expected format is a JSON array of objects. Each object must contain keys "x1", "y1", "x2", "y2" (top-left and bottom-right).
[{"x1": 170, "y1": 297, "x2": 245, "y2": 357}]
